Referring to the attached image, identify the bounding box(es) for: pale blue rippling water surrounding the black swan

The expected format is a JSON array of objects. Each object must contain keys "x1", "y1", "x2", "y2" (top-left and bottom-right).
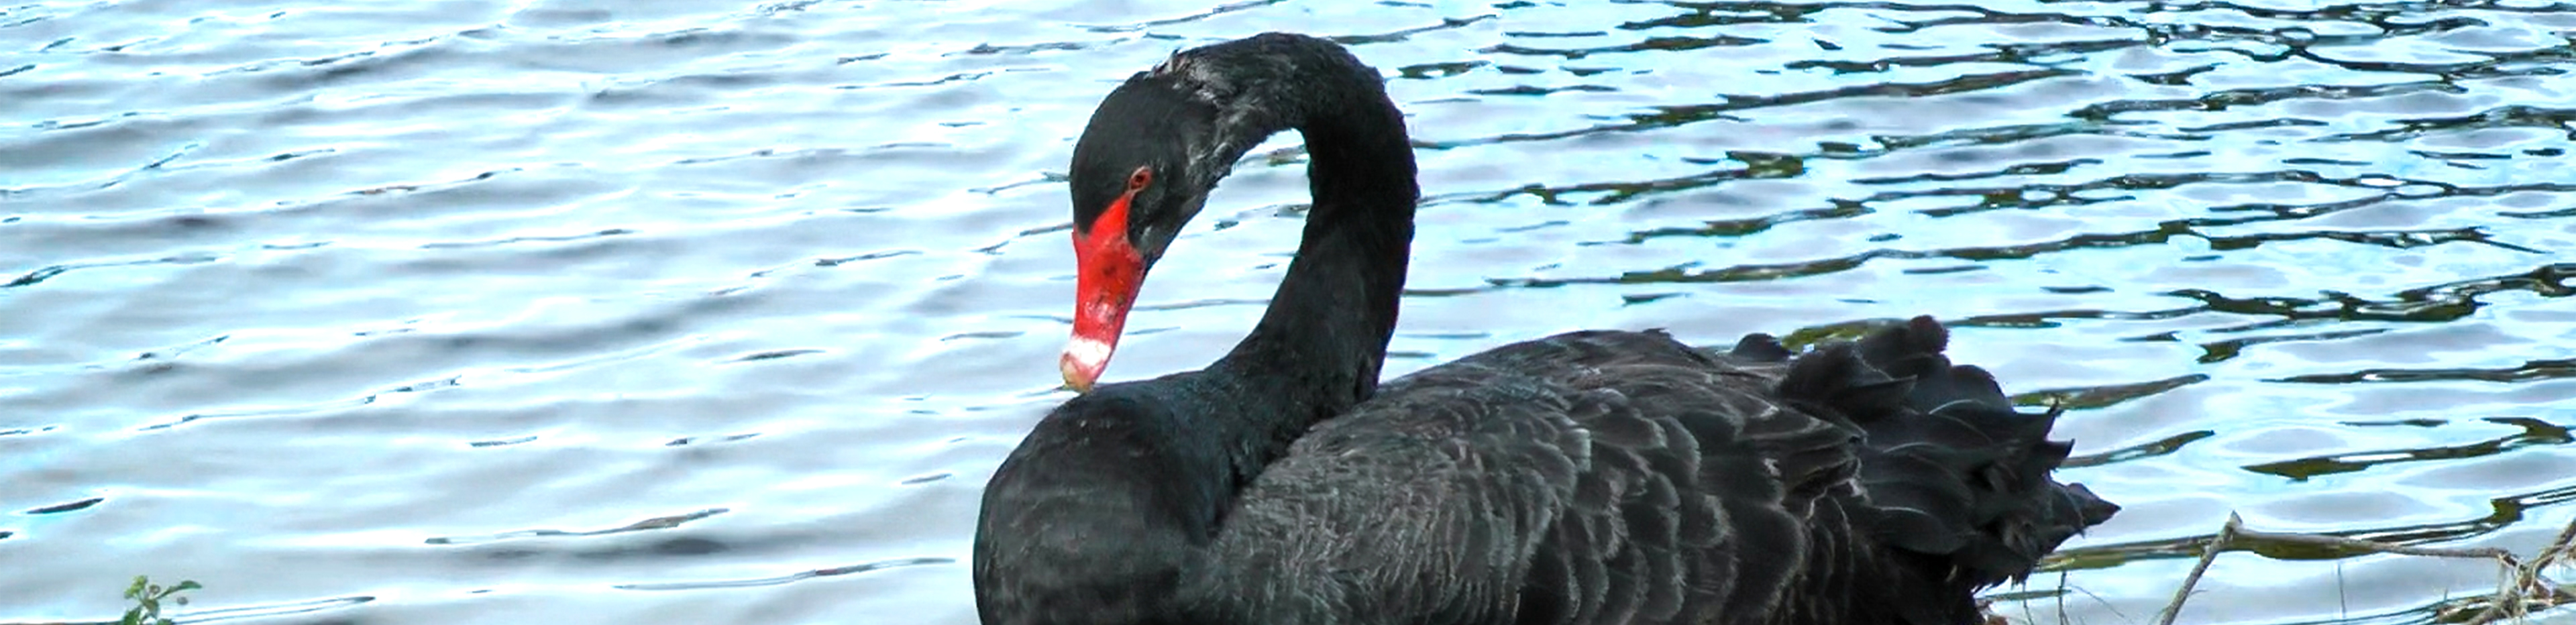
[{"x1": 0, "y1": 0, "x2": 2576, "y2": 625}]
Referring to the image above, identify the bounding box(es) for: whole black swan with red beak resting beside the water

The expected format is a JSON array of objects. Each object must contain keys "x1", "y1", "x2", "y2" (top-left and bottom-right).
[{"x1": 974, "y1": 34, "x2": 2117, "y2": 625}]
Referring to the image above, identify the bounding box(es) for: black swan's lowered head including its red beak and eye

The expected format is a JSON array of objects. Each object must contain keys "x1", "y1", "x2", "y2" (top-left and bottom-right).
[{"x1": 1056, "y1": 67, "x2": 1234, "y2": 394}]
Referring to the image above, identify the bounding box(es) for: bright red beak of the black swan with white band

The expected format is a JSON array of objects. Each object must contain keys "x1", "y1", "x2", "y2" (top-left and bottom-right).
[{"x1": 1056, "y1": 188, "x2": 1144, "y2": 394}]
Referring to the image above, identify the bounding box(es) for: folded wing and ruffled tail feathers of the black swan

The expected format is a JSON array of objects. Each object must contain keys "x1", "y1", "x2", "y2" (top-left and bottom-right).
[{"x1": 1159, "y1": 319, "x2": 2115, "y2": 625}]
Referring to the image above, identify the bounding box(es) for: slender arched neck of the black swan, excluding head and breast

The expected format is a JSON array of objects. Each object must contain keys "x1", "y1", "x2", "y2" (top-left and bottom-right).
[{"x1": 1175, "y1": 36, "x2": 1422, "y2": 416}]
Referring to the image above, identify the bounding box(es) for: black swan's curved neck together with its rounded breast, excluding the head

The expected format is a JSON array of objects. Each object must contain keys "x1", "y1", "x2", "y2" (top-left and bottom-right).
[{"x1": 974, "y1": 34, "x2": 1422, "y2": 625}]
